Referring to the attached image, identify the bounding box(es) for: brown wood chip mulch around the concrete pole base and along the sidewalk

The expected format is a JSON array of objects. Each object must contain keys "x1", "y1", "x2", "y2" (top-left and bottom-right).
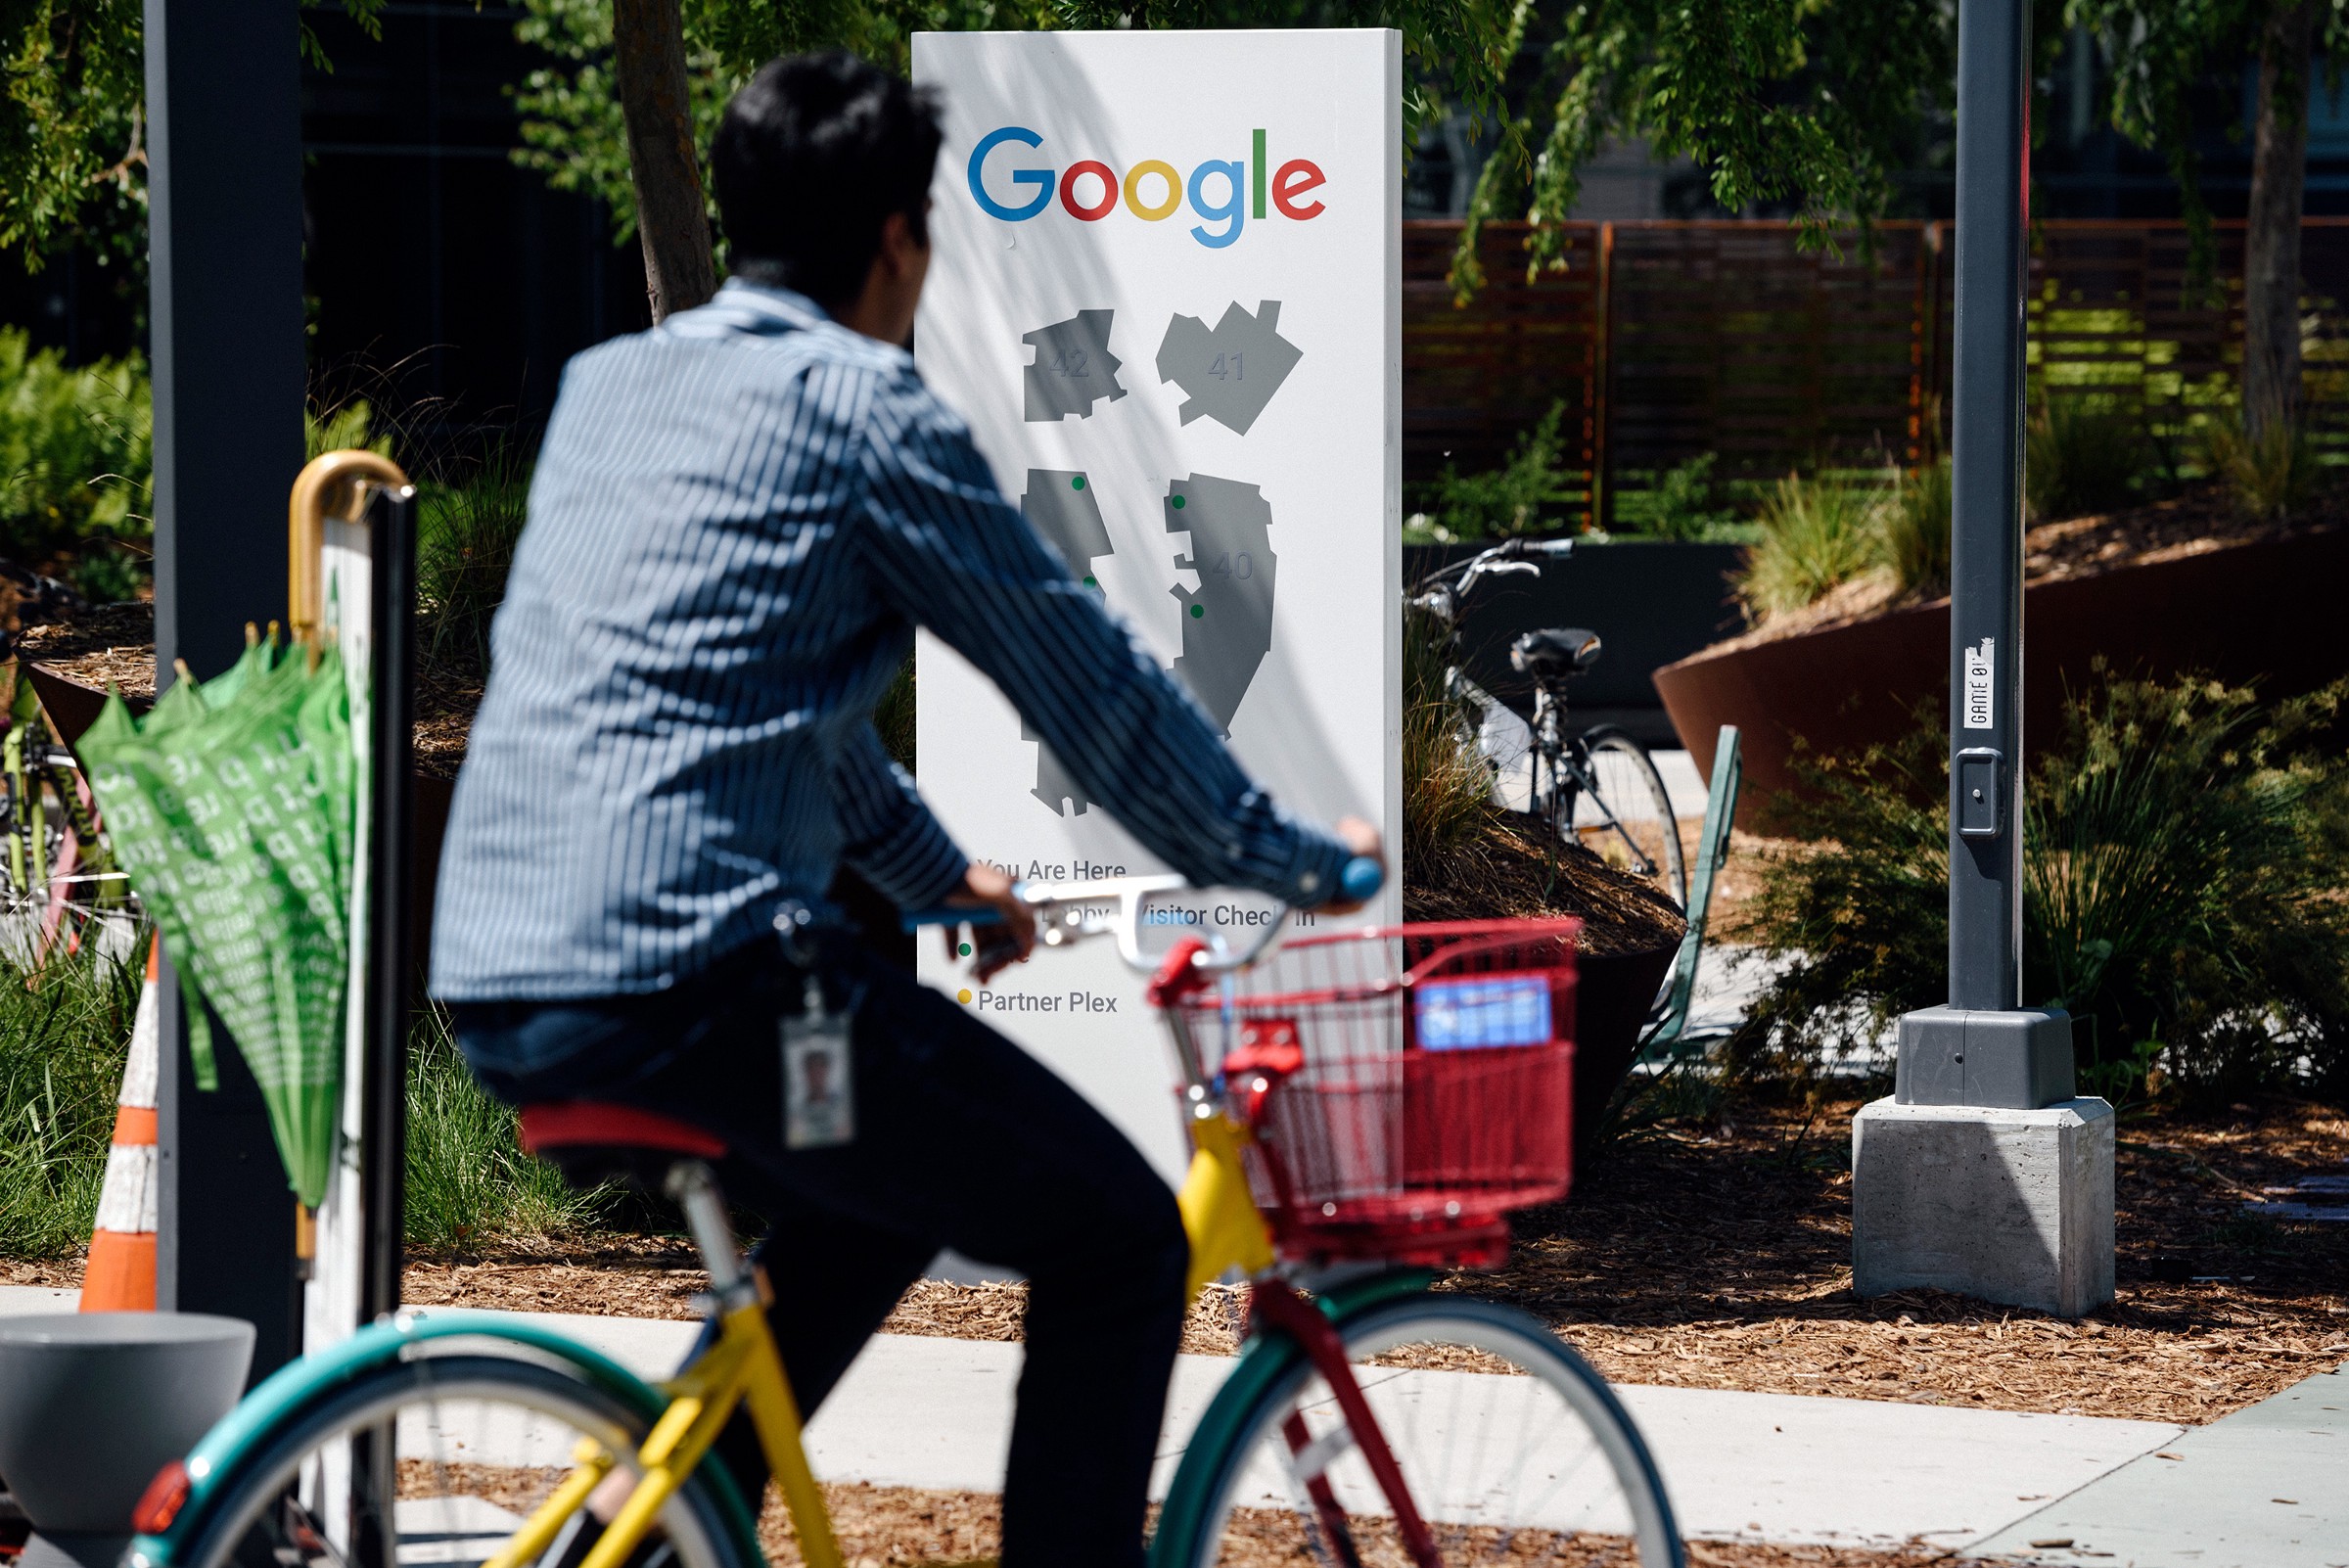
[{"x1": 380, "y1": 1098, "x2": 2349, "y2": 1425}]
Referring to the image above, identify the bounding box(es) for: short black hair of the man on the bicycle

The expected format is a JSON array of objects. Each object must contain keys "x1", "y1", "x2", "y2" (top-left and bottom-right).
[{"x1": 710, "y1": 49, "x2": 942, "y2": 310}]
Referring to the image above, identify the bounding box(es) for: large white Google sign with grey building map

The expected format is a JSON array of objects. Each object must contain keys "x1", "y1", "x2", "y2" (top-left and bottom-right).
[{"x1": 914, "y1": 28, "x2": 1403, "y2": 1176}]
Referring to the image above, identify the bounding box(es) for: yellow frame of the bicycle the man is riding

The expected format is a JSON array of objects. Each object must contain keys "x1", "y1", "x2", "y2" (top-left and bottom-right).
[{"x1": 482, "y1": 1103, "x2": 1273, "y2": 1568}]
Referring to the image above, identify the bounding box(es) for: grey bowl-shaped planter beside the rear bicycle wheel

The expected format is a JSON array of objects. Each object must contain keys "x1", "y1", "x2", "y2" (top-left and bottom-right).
[{"x1": 0, "y1": 1313, "x2": 253, "y2": 1568}]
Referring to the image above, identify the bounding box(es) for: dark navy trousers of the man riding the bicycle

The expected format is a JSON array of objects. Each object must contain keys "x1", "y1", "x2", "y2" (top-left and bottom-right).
[{"x1": 456, "y1": 942, "x2": 1188, "y2": 1568}]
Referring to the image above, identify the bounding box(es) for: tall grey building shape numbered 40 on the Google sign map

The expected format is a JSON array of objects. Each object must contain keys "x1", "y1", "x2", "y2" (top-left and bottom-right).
[{"x1": 1165, "y1": 474, "x2": 1278, "y2": 735}]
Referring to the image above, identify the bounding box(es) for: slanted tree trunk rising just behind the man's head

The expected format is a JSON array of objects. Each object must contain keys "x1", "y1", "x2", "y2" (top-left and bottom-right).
[{"x1": 611, "y1": 0, "x2": 709, "y2": 322}]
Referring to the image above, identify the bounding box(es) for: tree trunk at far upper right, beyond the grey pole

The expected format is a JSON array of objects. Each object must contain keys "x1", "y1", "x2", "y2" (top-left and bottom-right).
[{"x1": 2243, "y1": 0, "x2": 2319, "y2": 437}]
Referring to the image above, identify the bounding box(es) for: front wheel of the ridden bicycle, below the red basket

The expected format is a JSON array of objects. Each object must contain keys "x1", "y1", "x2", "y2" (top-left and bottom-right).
[{"x1": 1151, "y1": 1296, "x2": 1684, "y2": 1568}]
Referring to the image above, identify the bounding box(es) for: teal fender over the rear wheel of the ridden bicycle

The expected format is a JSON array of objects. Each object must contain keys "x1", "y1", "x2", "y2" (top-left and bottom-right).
[{"x1": 129, "y1": 1308, "x2": 681, "y2": 1568}]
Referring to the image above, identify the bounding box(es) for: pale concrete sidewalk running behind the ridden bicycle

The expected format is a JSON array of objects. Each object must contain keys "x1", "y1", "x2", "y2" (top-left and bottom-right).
[{"x1": 0, "y1": 1289, "x2": 2349, "y2": 1568}]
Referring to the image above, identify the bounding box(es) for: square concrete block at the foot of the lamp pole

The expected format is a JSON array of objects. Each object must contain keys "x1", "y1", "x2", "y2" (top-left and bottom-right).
[{"x1": 1851, "y1": 1098, "x2": 2112, "y2": 1316}]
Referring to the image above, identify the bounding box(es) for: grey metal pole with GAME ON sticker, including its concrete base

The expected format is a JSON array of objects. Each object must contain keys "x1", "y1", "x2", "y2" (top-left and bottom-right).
[{"x1": 1851, "y1": 0, "x2": 2112, "y2": 1313}]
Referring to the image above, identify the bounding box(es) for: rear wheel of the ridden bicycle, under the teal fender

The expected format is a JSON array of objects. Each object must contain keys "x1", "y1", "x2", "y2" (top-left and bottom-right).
[{"x1": 169, "y1": 1355, "x2": 761, "y2": 1568}]
